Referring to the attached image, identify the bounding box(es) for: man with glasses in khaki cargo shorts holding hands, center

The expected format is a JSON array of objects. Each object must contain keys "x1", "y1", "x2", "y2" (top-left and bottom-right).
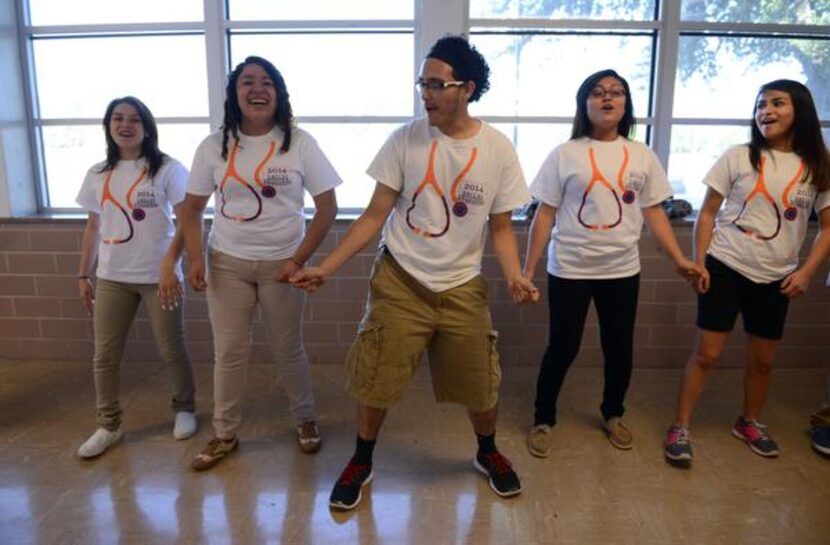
[{"x1": 291, "y1": 36, "x2": 539, "y2": 509}]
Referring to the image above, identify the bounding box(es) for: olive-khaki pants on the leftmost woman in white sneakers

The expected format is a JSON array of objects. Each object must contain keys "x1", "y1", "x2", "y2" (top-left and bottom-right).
[{"x1": 93, "y1": 278, "x2": 195, "y2": 431}]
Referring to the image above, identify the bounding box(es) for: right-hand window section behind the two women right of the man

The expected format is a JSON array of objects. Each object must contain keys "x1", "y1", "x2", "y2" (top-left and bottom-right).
[{"x1": 470, "y1": 0, "x2": 830, "y2": 208}]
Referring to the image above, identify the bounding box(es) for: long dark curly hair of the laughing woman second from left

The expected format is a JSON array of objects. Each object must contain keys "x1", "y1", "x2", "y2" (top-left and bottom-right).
[{"x1": 222, "y1": 55, "x2": 294, "y2": 159}]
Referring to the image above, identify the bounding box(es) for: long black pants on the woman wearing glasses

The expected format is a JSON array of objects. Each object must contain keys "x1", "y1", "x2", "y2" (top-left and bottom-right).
[{"x1": 534, "y1": 274, "x2": 640, "y2": 426}]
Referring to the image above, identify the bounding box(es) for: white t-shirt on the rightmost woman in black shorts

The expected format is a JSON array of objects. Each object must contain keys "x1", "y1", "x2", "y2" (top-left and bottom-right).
[{"x1": 703, "y1": 144, "x2": 830, "y2": 284}]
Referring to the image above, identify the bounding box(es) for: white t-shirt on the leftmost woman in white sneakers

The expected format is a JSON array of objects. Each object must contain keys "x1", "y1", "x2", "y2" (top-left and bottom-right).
[{"x1": 75, "y1": 157, "x2": 187, "y2": 284}]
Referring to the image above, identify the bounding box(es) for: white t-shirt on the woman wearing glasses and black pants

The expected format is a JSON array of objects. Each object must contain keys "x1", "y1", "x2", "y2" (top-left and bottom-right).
[{"x1": 530, "y1": 137, "x2": 672, "y2": 279}]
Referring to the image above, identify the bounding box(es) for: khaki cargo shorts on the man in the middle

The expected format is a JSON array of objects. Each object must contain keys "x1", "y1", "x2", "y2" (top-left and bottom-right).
[{"x1": 346, "y1": 251, "x2": 501, "y2": 412}]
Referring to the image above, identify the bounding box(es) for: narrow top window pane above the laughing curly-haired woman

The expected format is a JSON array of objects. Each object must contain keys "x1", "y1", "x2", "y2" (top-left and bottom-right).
[{"x1": 229, "y1": 0, "x2": 415, "y2": 21}]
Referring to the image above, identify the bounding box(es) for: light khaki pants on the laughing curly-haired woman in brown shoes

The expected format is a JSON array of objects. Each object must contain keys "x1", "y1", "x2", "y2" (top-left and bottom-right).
[{"x1": 207, "y1": 249, "x2": 315, "y2": 439}]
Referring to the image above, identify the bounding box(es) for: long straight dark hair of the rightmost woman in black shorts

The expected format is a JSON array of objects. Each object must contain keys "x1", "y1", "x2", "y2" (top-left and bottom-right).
[{"x1": 749, "y1": 79, "x2": 830, "y2": 191}]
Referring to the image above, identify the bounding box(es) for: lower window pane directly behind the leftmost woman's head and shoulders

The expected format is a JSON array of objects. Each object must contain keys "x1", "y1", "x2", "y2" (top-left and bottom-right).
[{"x1": 42, "y1": 124, "x2": 210, "y2": 208}]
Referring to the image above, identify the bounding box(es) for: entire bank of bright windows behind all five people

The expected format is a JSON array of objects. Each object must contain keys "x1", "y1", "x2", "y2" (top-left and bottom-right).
[{"x1": 16, "y1": 0, "x2": 830, "y2": 211}]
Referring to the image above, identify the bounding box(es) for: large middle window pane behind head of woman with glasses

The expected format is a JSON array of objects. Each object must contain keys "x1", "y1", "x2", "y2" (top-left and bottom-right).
[{"x1": 473, "y1": 35, "x2": 652, "y2": 117}]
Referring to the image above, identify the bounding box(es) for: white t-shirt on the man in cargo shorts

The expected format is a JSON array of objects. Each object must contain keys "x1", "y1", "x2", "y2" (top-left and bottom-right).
[{"x1": 367, "y1": 118, "x2": 530, "y2": 292}]
